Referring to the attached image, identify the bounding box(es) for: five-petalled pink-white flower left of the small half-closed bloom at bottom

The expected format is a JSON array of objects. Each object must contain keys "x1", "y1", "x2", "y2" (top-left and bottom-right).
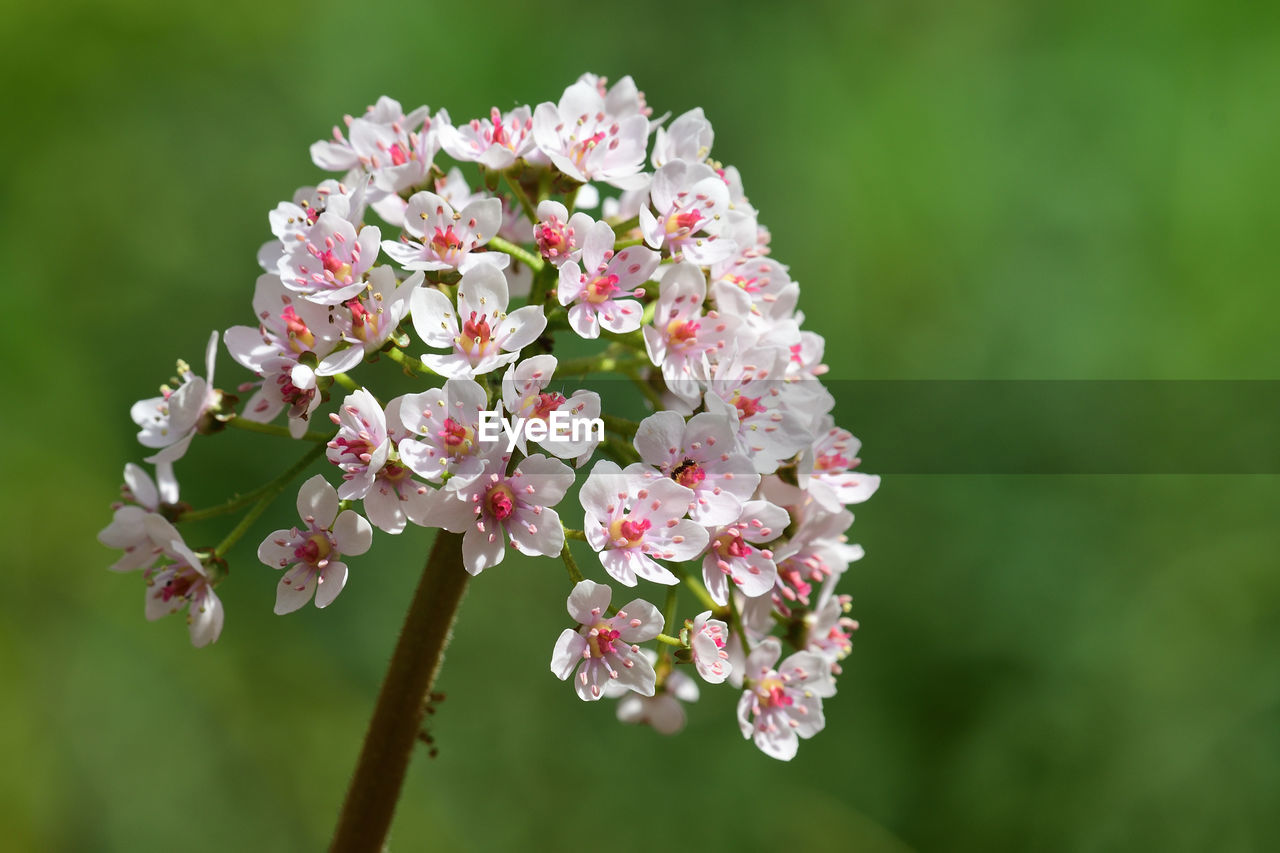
[{"x1": 552, "y1": 580, "x2": 663, "y2": 702}]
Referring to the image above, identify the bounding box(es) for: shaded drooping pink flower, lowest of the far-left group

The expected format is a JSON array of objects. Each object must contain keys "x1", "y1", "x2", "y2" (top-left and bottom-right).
[{"x1": 146, "y1": 515, "x2": 223, "y2": 648}]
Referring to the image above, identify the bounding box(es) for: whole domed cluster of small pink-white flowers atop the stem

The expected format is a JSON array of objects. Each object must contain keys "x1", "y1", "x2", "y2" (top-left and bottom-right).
[{"x1": 100, "y1": 74, "x2": 879, "y2": 760}]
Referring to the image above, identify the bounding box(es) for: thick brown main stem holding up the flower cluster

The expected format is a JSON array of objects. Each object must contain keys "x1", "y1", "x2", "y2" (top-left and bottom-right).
[{"x1": 329, "y1": 530, "x2": 470, "y2": 853}]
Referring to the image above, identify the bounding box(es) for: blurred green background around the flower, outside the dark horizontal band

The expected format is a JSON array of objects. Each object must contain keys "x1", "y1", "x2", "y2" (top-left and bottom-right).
[{"x1": 0, "y1": 0, "x2": 1280, "y2": 852}]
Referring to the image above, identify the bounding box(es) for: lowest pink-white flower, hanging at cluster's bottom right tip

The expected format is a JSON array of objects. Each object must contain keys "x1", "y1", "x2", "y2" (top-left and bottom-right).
[{"x1": 737, "y1": 637, "x2": 836, "y2": 761}]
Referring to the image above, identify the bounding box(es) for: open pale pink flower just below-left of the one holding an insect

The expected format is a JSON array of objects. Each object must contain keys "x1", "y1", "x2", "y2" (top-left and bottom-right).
[{"x1": 579, "y1": 460, "x2": 707, "y2": 587}]
